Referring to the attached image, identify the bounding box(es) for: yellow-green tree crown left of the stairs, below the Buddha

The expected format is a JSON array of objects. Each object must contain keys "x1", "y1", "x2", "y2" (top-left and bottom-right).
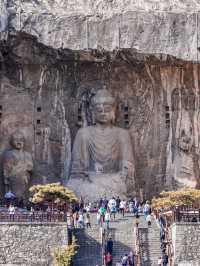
[{"x1": 29, "y1": 183, "x2": 77, "y2": 204}]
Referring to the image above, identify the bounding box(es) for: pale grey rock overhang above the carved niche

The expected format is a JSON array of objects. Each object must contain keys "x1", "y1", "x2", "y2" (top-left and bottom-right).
[{"x1": 1, "y1": 0, "x2": 200, "y2": 61}]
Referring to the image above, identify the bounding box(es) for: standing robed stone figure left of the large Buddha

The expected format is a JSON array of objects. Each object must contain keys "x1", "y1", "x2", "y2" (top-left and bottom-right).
[{"x1": 3, "y1": 131, "x2": 33, "y2": 199}]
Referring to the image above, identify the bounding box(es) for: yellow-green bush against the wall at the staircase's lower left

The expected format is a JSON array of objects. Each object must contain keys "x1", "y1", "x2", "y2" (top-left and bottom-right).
[{"x1": 53, "y1": 236, "x2": 78, "y2": 266}]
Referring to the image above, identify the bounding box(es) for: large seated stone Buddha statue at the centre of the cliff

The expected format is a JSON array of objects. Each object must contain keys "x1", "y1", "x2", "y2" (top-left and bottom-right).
[{"x1": 68, "y1": 89, "x2": 134, "y2": 199}]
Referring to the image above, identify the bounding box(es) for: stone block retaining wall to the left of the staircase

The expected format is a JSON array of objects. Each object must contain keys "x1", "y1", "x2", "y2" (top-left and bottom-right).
[{"x1": 0, "y1": 223, "x2": 68, "y2": 266}]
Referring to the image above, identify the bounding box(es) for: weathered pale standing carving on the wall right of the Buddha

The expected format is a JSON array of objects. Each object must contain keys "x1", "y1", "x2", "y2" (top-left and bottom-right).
[{"x1": 171, "y1": 88, "x2": 199, "y2": 187}]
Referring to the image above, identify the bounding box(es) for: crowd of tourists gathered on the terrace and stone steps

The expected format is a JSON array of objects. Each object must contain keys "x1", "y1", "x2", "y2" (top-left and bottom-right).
[{"x1": 3, "y1": 194, "x2": 168, "y2": 266}]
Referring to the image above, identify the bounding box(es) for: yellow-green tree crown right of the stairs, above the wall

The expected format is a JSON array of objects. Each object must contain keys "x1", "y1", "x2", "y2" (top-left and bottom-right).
[{"x1": 152, "y1": 188, "x2": 200, "y2": 209}]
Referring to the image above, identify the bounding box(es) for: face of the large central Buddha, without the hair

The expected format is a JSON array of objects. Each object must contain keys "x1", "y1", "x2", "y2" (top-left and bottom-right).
[{"x1": 94, "y1": 103, "x2": 114, "y2": 125}]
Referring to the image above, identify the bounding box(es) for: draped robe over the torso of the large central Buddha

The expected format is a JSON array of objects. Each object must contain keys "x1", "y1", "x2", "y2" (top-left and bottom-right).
[{"x1": 71, "y1": 126, "x2": 134, "y2": 177}]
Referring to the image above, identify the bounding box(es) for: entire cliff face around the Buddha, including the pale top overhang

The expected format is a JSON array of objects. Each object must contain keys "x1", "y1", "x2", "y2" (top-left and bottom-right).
[{"x1": 0, "y1": 0, "x2": 200, "y2": 200}]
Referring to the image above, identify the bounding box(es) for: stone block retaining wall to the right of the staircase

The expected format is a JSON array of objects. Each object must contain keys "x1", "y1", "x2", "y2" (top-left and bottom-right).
[{"x1": 172, "y1": 223, "x2": 200, "y2": 266}]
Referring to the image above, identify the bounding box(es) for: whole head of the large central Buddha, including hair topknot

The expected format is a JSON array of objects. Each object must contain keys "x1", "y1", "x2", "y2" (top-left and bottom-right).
[{"x1": 92, "y1": 89, "x2": 115, "y2": 125}]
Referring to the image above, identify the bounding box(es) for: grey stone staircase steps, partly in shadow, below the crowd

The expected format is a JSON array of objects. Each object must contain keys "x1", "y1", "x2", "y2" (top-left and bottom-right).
[{"x1": 73, "y1": 214, "x2": 134, "y2": 266}]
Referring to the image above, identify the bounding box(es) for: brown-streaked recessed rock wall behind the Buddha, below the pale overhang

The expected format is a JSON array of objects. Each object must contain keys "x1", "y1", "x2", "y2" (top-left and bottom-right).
[{"x1": 0, "y1": 33, "x2": 200, "y2": 197}]
